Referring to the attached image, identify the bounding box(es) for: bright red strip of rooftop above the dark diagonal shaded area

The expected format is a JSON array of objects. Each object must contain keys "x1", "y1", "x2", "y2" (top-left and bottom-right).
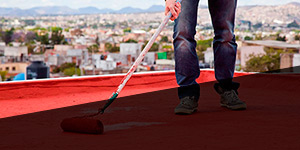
[{"x1": 0, "y1": 70, "x2": 246, "y2": 118}]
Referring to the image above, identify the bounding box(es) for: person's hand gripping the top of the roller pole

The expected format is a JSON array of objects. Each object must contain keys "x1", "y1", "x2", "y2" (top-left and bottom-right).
[{"x1": 165, "y1": 0, "x2": 181, "y2": 21}]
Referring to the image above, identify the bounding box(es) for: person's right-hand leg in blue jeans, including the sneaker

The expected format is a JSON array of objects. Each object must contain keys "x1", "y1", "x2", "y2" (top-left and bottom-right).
[{"x1": 208, "y1": 0, "x2": 247, "y2": 110}]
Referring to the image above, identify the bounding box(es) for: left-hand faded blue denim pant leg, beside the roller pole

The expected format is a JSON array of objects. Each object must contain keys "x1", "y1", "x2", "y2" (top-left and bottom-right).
[{"x1": 173, "y1": 0, "x2": 200, "y2": 98}]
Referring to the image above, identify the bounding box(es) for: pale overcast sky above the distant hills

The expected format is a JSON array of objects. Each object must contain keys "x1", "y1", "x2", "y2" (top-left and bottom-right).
[{"x1": 0, "y1": 0, "x2": 300, "y2": 9}]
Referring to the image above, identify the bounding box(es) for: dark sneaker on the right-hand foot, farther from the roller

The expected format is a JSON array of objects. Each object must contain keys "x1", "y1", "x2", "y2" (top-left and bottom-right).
[{"x1": 215, "y1": 84, "x2": 247, "y2": 110}]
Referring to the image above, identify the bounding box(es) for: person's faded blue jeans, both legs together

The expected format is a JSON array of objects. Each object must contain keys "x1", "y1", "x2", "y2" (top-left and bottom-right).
[{"x1": 173, "y1": 0, "x2": 237, "y2": 98}]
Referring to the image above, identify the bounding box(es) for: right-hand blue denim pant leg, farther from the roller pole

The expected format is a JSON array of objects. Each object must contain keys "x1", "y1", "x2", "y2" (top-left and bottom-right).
[{"x1": 208, "y1": 0, "x2": 237, "y2": 86}]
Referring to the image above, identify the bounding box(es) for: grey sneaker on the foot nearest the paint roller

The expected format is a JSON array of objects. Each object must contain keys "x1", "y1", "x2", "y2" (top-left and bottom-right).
[{"x1": 174, "y1": 96, "x2": 198, "y2": 115}]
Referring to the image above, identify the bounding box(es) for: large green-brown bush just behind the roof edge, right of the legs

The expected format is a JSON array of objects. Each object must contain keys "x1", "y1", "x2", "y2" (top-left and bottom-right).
[{"x1": 244, "y1": 48, "x2": 283, "y2": 72}]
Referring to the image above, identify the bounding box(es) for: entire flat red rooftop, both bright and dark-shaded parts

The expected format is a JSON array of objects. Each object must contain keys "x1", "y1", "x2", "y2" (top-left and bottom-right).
[{"x1": 0, "y1": 70, "x2": 300, "y2": 150}]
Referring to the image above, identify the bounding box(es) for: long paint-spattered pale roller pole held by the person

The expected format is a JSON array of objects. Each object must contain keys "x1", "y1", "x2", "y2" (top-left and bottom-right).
[{"x1": 99, "y1": 0, "x2": 182, "y2": 114}]
